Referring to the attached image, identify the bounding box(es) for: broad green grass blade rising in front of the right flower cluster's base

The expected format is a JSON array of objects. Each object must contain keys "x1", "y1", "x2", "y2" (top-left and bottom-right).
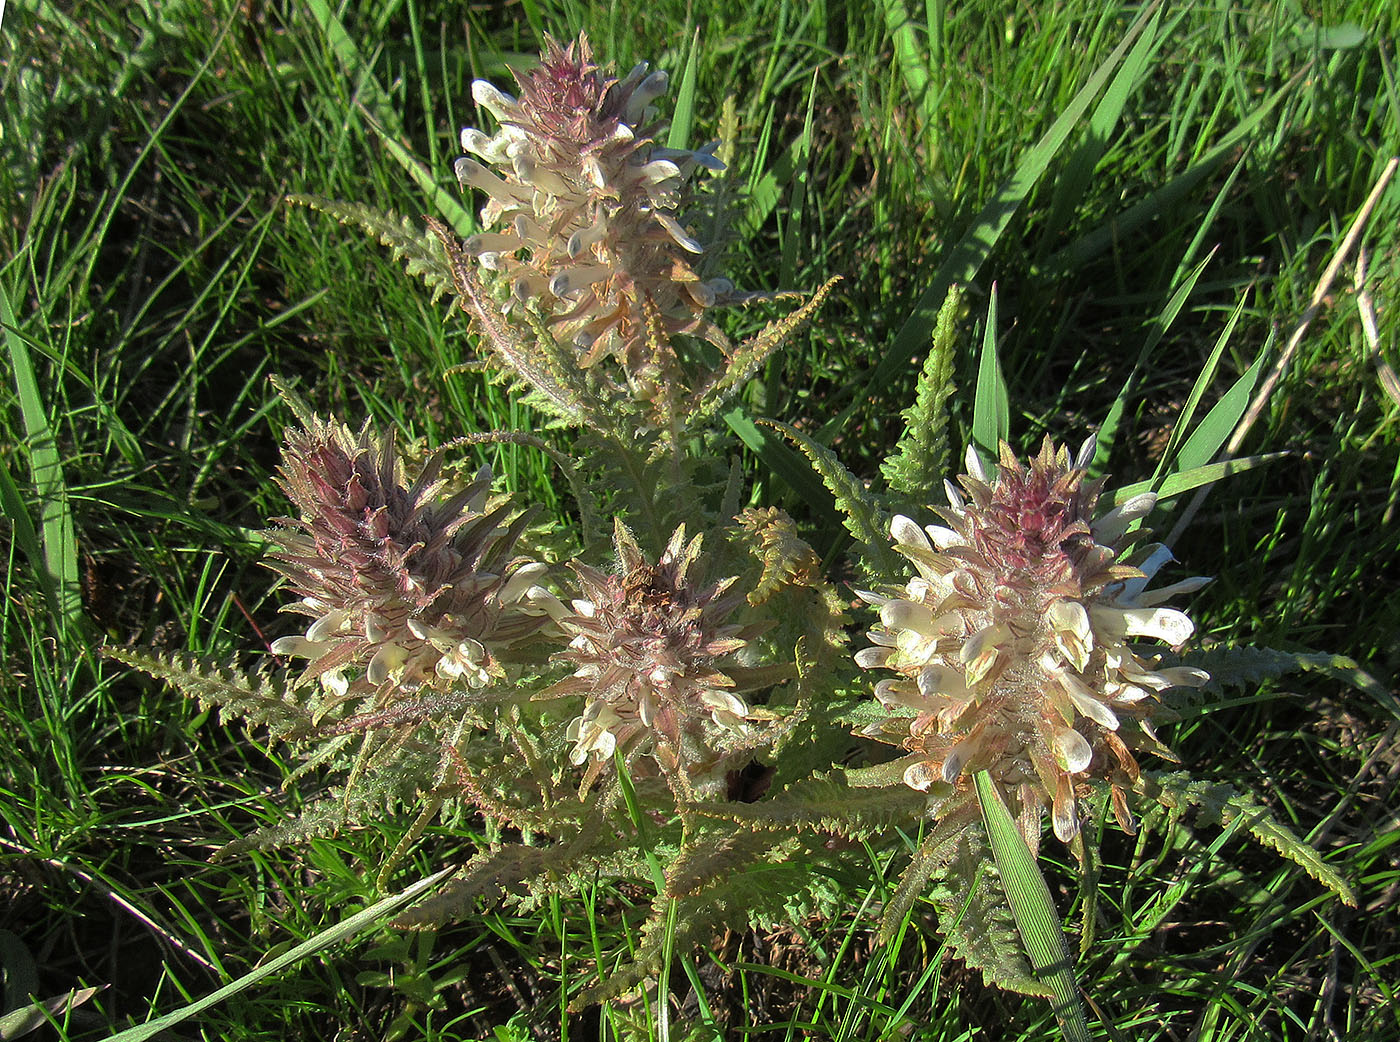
[{"x1": 977, "y1": 770, "x2": 1089, "y2": 1042}]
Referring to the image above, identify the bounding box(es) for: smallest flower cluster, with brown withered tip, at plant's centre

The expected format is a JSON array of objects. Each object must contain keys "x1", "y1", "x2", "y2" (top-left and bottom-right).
[{"x1": 549, "y1": 524, "x2": 766, "y2": 773}]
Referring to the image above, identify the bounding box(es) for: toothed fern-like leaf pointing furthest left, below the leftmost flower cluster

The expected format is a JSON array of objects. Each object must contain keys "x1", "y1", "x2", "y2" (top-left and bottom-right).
[{"x1": 104, "y1": 647, "x2": 315, "y2": 741}]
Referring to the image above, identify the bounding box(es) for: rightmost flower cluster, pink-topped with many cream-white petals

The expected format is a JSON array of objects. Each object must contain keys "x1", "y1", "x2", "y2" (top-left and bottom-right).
[{"x1": 855, "y1": 438, "x2": 1208, "y2": 849}]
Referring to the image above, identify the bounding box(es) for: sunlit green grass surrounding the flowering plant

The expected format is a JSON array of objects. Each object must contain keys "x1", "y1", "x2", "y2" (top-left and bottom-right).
[{"x1": 0, "y1": 0, "x2": 1400, "y2": 1039}]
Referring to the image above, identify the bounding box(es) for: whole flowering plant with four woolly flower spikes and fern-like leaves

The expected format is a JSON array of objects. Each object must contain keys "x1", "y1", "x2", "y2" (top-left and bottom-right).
[{"x1": 115, "y1": 30, "x2": 1351, "y2": 1025}]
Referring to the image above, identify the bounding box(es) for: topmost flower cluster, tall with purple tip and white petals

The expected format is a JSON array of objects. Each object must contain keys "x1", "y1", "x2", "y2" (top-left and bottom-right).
[{"x1": 456, "y1": 36, "x2": 734, "y2": 398}]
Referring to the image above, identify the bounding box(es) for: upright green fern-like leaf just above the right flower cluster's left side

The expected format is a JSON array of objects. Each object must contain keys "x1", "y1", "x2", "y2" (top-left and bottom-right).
[{"x1": 881, "y1": 286, "x2": 960, "y2": 506}]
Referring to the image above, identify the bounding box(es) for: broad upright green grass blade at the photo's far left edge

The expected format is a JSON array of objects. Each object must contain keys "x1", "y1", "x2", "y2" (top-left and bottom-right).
[{"x1": 0, "y1": 278, "x2": 83, "y2": 636}]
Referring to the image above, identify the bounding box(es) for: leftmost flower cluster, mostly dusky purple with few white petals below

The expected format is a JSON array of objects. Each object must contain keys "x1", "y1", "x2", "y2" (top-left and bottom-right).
[{"x1": 270, "y1": 420, "x2": 552, "y2": 695}]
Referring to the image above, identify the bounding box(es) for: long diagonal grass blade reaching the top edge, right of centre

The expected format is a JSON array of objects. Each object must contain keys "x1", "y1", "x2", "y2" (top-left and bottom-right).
[{"x1": 867, "y1": 0, "x2": 1161, "y2": 394}]
